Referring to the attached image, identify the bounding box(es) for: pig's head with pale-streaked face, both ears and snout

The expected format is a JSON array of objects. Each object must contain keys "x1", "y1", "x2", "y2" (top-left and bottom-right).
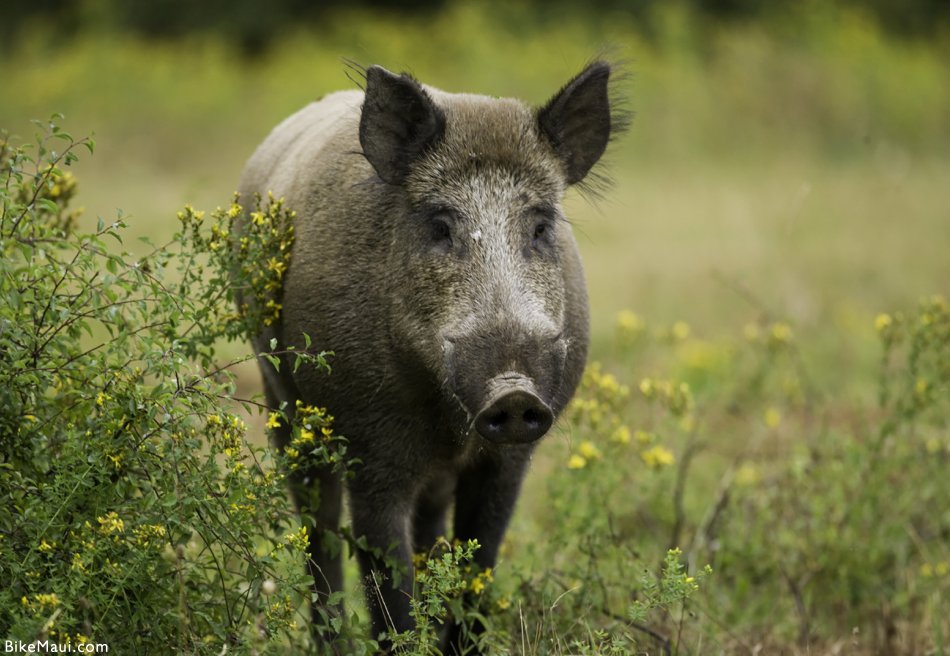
[{"x1": 359, "y1": 62, "x2": 616, "y2": 443}]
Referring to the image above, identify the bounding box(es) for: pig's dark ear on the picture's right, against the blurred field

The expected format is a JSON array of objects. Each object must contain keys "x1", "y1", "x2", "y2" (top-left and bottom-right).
[{"x1": 538, "y1": 61, "x2": 612, "y2": 184}]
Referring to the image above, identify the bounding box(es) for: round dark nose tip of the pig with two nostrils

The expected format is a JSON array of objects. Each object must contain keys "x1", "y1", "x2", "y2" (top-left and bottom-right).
[{"x1": 475, "y1": 373, "x2": 554, "y2": 444}]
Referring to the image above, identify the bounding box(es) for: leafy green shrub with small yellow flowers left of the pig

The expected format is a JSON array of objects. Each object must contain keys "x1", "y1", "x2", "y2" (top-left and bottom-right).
[{"x1": 0, "y1": 119, "x2": 321, "y2": 654}]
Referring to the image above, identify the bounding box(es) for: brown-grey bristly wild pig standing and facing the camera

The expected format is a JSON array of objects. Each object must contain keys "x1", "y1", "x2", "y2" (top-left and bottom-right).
[{"x1": 239, "y1": 61, "x2": 619, "y2": 652}]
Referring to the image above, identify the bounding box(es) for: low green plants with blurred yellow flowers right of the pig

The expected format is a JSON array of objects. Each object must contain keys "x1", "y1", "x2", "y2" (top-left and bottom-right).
[{"x1": 480, "y1": 297, "x2": 950, "y2": 654}]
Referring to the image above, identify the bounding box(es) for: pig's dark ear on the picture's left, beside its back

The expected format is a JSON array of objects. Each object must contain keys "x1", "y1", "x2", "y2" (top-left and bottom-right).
[{"x1": 360, "y1": 66, "x2": 445, "y2": 184}]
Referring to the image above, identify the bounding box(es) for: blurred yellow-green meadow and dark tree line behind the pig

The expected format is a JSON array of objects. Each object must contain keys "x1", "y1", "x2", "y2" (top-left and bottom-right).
[{"x1": 0, "y1": 0, "x2": 950, "y2": 653}]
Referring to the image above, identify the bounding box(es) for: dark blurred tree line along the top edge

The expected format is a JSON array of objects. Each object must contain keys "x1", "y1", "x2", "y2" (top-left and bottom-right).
[{"x1": 0, "y1": 0, "x2": 950, "y2": 57}]
